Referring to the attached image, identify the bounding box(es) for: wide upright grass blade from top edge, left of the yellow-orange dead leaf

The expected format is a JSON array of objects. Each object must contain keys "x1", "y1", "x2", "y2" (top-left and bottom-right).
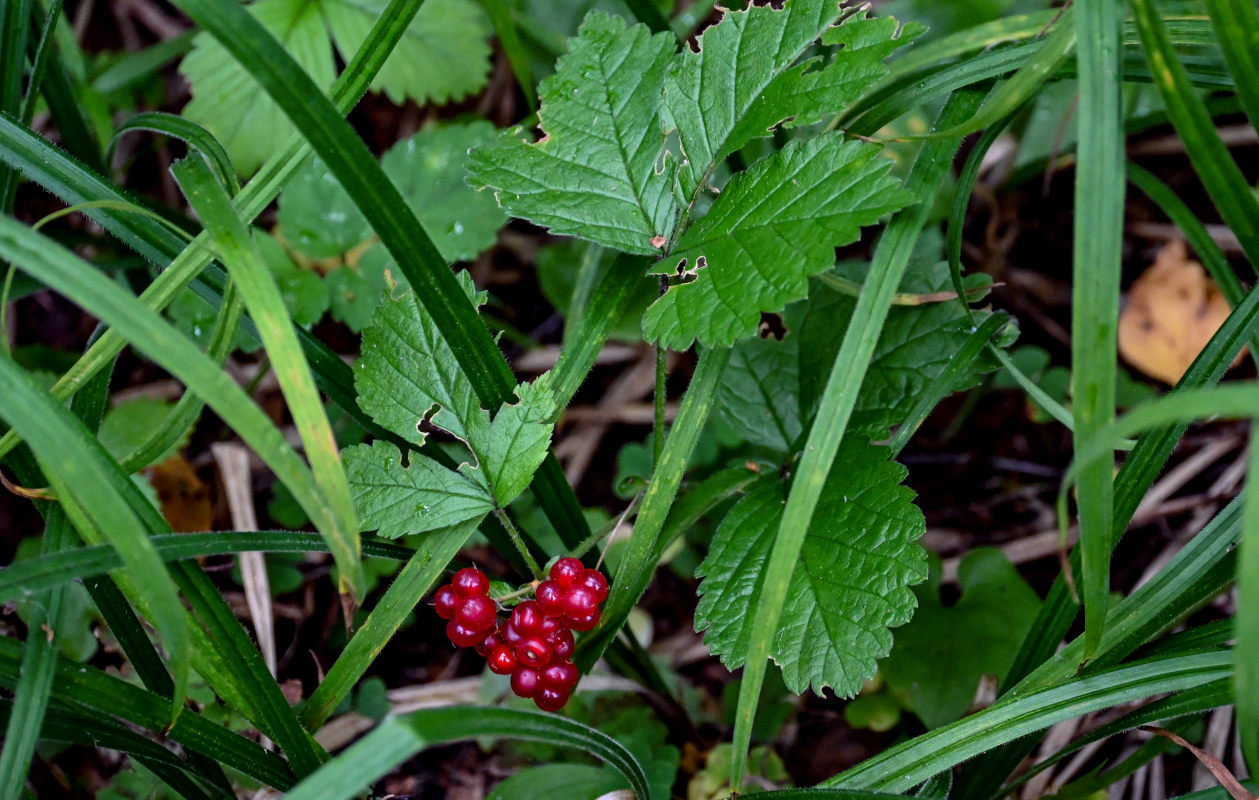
[{"x1": 1071, "y1": 0, "x2": 1127, "y2": 658}]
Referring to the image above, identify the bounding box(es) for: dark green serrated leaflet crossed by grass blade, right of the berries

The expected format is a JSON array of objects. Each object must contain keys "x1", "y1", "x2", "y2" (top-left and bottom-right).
[{"x1": 695, "y1": 437, "x2": 927, "y2": 697}]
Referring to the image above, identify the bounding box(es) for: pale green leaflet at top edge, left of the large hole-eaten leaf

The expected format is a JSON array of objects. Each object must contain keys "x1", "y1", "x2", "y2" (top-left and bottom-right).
[{"x1": 320, "y1": 0, "x2": 492, "y2": 105}]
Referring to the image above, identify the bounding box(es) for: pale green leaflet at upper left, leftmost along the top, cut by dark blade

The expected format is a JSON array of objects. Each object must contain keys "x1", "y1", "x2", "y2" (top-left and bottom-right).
[{"x1": 179, "y1": 0, "x2": 336, "y2": 175}]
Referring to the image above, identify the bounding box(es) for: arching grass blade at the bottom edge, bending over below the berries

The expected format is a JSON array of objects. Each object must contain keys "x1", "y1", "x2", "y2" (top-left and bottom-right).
[{"x1": 287, "y1": 706, "x2": 651, "y2": 800}]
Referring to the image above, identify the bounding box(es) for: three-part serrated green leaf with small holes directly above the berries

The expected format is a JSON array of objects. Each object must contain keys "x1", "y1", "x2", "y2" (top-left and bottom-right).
[{"x1": 345, "y1": 272, "x2": 556, "y2": 537}]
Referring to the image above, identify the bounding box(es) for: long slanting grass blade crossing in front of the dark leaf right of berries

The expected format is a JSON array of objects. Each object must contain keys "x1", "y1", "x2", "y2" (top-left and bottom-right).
[{"x1": 730, "y1": 92, "x2": 982, "y2": 789}]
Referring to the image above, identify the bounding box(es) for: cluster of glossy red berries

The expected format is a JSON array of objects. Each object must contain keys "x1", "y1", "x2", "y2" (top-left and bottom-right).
[{"x1": 433, "y1": 558, "x2": 608, "y2": 711}]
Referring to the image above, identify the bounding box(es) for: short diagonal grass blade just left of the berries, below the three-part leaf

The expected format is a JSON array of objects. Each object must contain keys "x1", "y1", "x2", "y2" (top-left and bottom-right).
[{"x1": 302, "y1": 520, "x2": 476, "y2": 731}]
